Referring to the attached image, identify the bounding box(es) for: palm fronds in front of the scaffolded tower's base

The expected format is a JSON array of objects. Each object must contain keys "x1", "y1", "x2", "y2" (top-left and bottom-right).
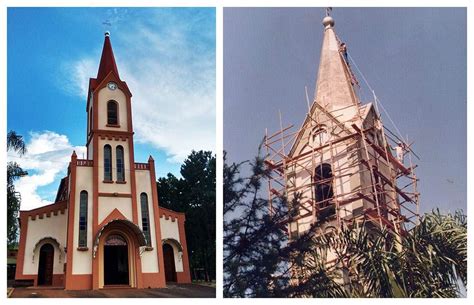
[{"x1": 292, "y1": 210, "x2": 467, "y2": 297}]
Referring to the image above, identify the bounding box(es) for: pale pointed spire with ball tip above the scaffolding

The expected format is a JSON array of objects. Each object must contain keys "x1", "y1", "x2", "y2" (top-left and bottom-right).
[{"x1": 314, "y1": 13, "x2": 358, "y2": 111}]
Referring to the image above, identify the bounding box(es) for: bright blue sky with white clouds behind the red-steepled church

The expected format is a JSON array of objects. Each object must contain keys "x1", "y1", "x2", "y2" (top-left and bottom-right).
[{"x1": 7, "y1": 8, "x2": 216, "y2": 209}]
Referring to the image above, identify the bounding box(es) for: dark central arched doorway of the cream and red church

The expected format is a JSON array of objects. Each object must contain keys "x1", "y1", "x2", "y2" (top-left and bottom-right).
[{"x1": 104, "y1": 234, "x2": 129, "y2": 285}]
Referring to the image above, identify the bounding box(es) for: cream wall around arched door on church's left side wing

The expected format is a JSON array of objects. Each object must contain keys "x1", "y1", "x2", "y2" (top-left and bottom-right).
[{"x1": 23, "y1": 210, "x2": 67, "y2": 275}]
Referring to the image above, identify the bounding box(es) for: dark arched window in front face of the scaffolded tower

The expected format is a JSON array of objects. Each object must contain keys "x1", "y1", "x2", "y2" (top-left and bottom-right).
[{"x1": 314, "y1": 163, "x2": 335, "y2": 220}]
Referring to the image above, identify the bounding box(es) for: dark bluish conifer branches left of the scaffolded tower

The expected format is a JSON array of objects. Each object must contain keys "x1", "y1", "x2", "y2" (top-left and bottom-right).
[{"x1": 224, "y1": 154, "x2": 302, "y2": 297}]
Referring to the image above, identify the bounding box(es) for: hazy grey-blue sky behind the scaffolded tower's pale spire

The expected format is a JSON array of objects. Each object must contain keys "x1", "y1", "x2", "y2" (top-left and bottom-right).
[{"x1": 224, "y1": 8, "x2": 467, "y2": 211}]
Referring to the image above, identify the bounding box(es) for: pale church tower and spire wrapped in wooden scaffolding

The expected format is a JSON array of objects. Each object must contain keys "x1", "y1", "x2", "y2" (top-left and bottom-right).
[{"x1": 265, "y1": 10, "x2": 419, "y2": 254}]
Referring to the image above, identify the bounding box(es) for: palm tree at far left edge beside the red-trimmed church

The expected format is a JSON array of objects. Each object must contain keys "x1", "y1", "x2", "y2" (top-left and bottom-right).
[{"x1": 7, "y1": 130, "x2": 28, "y2": 246}]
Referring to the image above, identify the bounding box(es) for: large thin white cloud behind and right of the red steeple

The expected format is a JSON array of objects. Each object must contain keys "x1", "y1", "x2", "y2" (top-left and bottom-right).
[{"x1": 66, "y1": 9, "x2": 216, "y2": 162}]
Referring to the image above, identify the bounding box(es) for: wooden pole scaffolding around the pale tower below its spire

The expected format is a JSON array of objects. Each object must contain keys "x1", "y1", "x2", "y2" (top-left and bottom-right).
[{"x1": 264, "y1": 94, "x2": 420, "y2": 239}]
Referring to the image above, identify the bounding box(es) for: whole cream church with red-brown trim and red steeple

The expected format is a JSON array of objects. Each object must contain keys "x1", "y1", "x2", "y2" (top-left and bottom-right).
[{"x1": 15, "y1": 32, "x2": 191, "y2": 290}]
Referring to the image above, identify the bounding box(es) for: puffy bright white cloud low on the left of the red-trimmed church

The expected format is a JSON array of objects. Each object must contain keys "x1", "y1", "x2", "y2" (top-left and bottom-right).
[{"x1": 8, "y1": 131, "x2": 86, "y2": 210}]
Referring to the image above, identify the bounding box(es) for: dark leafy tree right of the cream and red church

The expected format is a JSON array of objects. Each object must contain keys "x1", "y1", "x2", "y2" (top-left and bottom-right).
[{"x1": 157, "y1": 151, "x2": 216, "y2": 280}]
